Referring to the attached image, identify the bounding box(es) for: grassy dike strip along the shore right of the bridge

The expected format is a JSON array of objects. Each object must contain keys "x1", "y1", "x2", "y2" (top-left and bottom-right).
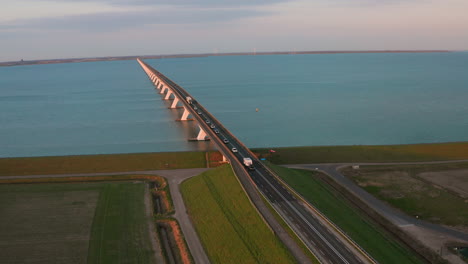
[{"x1": 253, "y1": 142, "x2": 468, "y2": 164}]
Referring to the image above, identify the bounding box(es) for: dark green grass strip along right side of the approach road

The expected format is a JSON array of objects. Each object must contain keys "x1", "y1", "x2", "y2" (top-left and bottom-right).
[{"x1": 268, "y1": 164, "x2": 423, "y2": 264}]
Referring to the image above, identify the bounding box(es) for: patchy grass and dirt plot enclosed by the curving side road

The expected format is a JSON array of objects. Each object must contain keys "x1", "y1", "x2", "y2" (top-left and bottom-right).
[{"x1": 342, "y1": 163, "x2": 468, "y2": 230}]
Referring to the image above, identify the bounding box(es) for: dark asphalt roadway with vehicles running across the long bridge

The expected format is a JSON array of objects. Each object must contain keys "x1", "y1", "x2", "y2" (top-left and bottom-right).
[{"x1": 141, "y1": 60, "x2": 365, "y2": 263}]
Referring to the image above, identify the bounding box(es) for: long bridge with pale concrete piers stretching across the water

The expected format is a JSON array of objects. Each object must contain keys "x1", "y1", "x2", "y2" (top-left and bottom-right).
[{"x1": 137, "y1": 59, "x2": 375, "y2": 264}]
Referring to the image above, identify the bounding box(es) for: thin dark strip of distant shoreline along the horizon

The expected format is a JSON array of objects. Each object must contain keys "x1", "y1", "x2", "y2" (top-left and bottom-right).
[{"x1": 0, "y1": 50, "x2": 452, "y2": 67}]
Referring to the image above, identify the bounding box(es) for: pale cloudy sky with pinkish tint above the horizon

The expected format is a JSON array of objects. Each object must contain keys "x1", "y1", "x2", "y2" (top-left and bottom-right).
[{"x1": 0, "y1": 0, "x2": 468, "y2": 61}]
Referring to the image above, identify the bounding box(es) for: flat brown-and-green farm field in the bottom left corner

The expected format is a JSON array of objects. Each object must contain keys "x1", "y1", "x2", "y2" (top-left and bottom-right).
[{"x1": 0, "y1": 182, "x2": 155, "y2": 264}]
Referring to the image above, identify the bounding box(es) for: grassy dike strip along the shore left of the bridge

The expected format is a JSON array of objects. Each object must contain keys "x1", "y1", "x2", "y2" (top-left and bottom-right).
[{"x1": 0, "y1": 152, "x2": 206, "y2": 176}]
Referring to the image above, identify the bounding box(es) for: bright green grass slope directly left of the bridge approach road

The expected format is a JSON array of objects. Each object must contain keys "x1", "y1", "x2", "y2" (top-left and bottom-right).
[{"x1": 181, "y1": 165, "x2": 295, "y2": 264}]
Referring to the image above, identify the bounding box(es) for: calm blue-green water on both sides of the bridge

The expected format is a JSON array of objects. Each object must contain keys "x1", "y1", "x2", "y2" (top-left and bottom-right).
[{"x1": 0, "y1": 52, "x2": 468, "y2": 157}]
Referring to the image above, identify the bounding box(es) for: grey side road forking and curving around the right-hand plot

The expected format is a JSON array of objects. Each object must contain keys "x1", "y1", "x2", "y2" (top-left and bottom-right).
[{"x1": 284, "y1": 163, "x2": 468, "y2": 242}]
